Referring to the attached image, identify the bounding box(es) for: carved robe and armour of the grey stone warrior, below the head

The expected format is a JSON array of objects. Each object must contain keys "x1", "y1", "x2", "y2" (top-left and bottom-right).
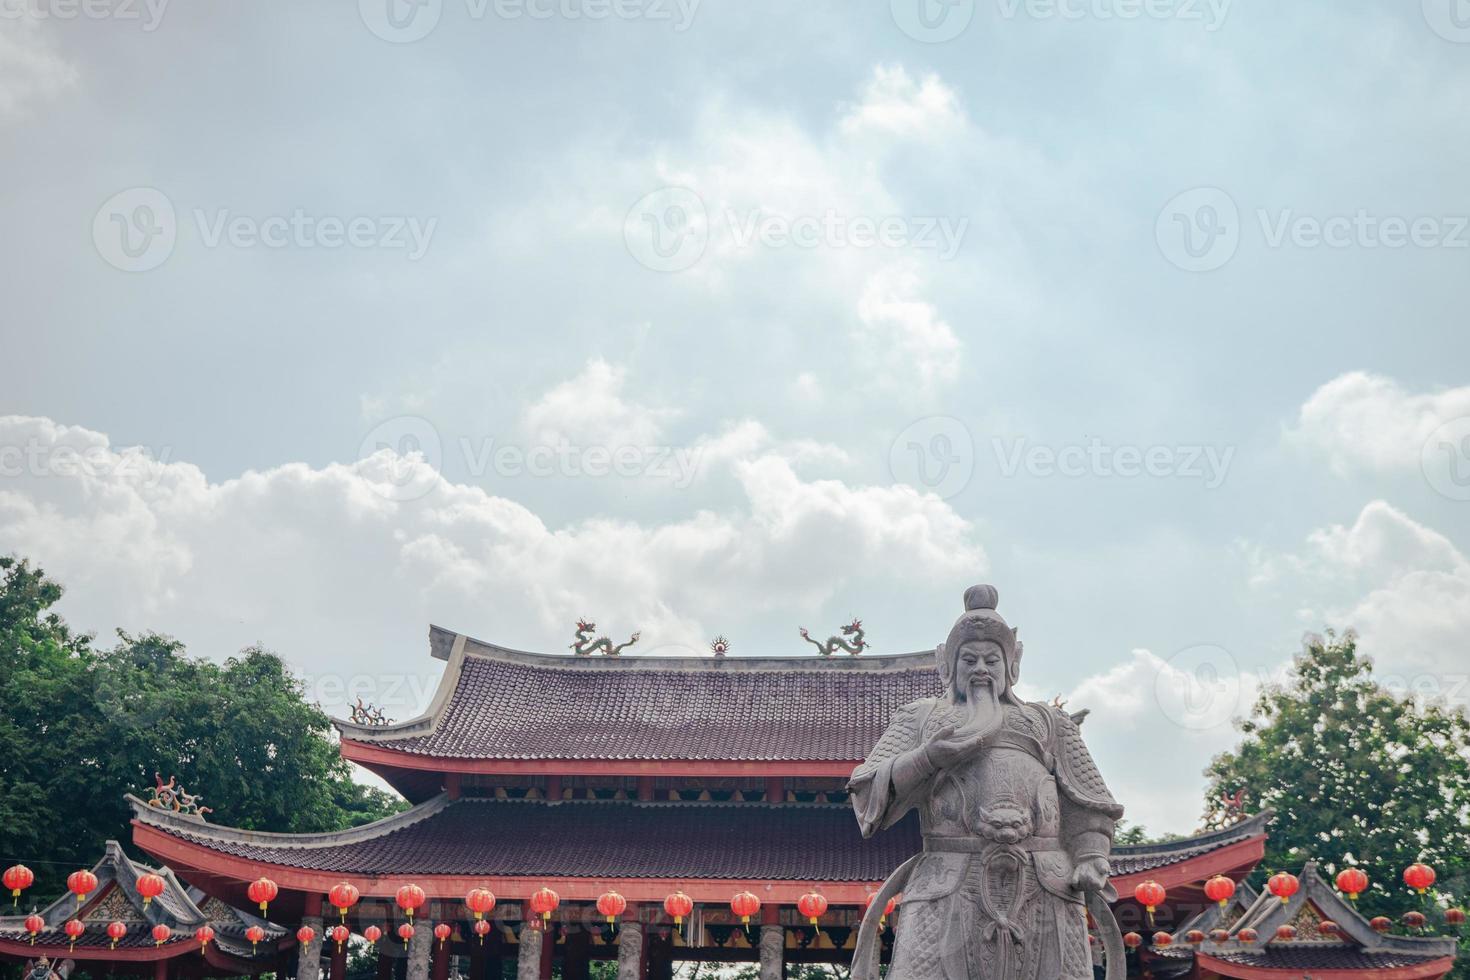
[{"x1": 848, "y1": 698, "x2": 1123, "y2": 980}]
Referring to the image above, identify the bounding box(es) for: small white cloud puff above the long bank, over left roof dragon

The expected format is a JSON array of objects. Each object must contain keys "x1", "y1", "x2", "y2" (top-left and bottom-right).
[{"x1": 523, "y1": 359, "x2": 678, "y2": 447}]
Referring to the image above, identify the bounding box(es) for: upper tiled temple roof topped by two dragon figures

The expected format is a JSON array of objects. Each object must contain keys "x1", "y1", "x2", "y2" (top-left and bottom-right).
[{"x1": 335, "y1": 627, "x2": 939, "y2": 768}]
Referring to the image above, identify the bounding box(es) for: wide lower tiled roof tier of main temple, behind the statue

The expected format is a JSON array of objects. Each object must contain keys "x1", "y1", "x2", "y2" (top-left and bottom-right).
[{"x1": 134, "y1": 795, "x2": 1267, "y2": 895}]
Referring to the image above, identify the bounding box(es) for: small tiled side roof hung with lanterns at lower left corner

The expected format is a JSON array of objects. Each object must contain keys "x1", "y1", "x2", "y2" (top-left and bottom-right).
[{"x1": 0, "y1": 840, "x2": 287, "y2": 959}]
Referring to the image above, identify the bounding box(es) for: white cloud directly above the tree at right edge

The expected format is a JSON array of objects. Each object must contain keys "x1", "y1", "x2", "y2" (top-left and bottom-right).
[{"x1": 1252, "y1": 501, "x2": 1470, "y2": 673}]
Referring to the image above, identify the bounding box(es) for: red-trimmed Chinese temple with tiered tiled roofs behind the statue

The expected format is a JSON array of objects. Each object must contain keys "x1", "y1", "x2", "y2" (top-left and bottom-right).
[{"x1": 0, "y1": 627, "x2": 1455, "y2": 980}]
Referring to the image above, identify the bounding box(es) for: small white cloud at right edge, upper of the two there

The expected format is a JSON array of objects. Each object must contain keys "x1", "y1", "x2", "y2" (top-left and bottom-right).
[{"x1": 1286, "y1": 372, "x2": 1470, "y2": 475}]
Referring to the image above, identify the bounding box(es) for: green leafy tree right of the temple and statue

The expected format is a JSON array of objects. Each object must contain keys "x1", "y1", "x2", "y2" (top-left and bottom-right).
[{"x1": 1205, "y1": 630, "x2": 1470, "y2": 952}]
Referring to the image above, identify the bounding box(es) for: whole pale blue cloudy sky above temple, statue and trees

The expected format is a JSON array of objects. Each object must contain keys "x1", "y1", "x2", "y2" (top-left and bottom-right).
[{"x1": 0, "y1": 0, "x2": 1470, "y2": 832}]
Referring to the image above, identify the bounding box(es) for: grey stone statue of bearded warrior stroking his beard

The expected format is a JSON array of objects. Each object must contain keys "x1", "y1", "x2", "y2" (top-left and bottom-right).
[{"x1": 848, "y1": 585, "x2": 1125, "y2": 980}]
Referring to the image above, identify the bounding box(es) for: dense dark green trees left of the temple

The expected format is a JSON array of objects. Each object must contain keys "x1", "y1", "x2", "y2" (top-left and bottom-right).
[{"x1": 0, "y1": 558, "x2": 403, "y2": 902}]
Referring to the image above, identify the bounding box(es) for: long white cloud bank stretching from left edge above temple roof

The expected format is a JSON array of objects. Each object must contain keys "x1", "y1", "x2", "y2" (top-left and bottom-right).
[{"x1": 0, "y1": 416, "x2": 985, "y2": 717}]
